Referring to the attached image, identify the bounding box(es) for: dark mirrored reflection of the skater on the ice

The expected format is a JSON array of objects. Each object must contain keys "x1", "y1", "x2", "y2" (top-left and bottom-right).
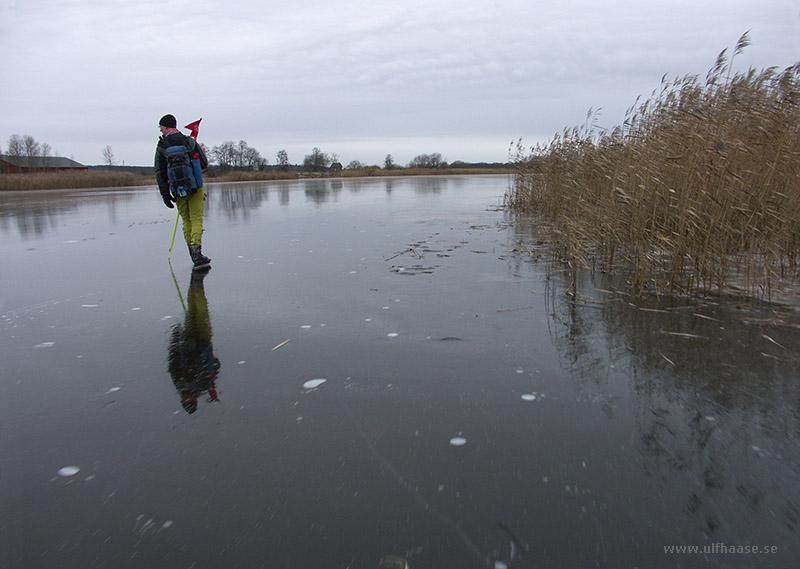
[{"x1": 167, "y1": 269, "x2": 221, "y2": 413}]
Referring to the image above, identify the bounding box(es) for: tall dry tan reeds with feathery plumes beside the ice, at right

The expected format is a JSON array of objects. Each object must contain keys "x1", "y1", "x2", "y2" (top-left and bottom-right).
[{"x1": 505, "y1": 34, "x2": 800, "y2": 299}]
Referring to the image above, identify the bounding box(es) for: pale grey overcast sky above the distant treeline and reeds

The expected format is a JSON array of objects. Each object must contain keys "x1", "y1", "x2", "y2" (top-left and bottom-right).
[{"x1": 0, "y1": 0, "x2": 800, "y2": 165}]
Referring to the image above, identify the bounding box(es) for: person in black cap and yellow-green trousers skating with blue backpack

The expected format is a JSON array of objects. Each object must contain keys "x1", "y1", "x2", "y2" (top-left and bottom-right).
[{"x1": 155, "y1": 115, "x2": 211, "y2": 268}]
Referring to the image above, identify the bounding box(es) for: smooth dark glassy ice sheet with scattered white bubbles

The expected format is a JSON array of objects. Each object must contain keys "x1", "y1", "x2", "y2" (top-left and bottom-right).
[{"x1": 0, "y1": 177, "x2": 800, "y2": 569}]
